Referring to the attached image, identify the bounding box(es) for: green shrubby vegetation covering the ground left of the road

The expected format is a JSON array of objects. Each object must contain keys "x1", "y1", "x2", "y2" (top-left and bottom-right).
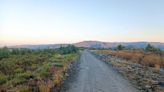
[{"x1": 0, "y1": 45, "x2": 78, "y2": 92}]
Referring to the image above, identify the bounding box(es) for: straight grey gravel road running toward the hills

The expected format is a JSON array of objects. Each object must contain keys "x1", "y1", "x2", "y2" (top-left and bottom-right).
[{"x1": 63, "y1": 51, "x2": 138, "y2": 92}]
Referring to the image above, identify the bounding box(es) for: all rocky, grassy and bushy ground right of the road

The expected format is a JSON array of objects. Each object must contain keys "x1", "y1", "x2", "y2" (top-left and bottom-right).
[{"x1": 94, "y1": 44, "x2": 164, "y2": 92}]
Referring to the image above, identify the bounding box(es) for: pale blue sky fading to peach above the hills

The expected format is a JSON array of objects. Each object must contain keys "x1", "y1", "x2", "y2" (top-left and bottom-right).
[{"x1": 0, "y1": 0, "x2": 164, "y2": 45}]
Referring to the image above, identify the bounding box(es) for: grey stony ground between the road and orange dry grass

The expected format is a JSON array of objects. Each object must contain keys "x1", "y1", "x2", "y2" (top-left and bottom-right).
[{"x1": 96, "y1": 54, "x2": 164, "y2": 92}]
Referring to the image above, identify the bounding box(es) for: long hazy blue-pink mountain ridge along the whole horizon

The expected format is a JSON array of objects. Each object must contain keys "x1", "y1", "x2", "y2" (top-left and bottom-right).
[{"x1": 1, "y1": 41, "x2": 164, "y2": 50}]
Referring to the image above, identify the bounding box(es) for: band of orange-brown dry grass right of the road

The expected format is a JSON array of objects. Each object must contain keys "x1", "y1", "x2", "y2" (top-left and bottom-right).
[{"x1": 96, "y1": 50, "x2": 164, "y2": 70}]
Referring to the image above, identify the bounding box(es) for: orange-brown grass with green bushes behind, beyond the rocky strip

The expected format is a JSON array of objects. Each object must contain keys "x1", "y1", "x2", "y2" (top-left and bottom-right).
[{"x1": 96, "y1": 44, "x2": 164, "y2": 67}]
